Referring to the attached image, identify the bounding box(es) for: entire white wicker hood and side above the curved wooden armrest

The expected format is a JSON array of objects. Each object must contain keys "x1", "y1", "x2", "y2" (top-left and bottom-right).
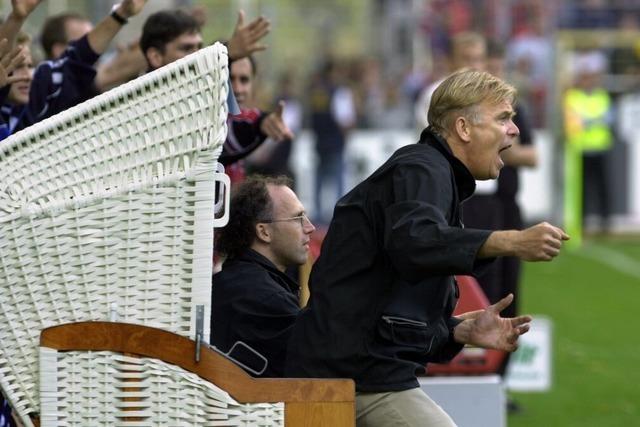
[{"x1": 0, "y1": 45, "x2": 228, "y2": 425}]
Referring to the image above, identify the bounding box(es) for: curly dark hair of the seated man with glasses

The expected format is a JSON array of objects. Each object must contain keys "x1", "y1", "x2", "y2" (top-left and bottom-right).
[{"x1": 216, "y1": 175, "x2": 291, "y2": 258}]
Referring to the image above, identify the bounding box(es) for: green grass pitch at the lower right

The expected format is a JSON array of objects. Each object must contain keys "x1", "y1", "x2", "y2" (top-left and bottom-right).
[{"x1": 509, "y1": 238, "x2": 640, "y2": 427}]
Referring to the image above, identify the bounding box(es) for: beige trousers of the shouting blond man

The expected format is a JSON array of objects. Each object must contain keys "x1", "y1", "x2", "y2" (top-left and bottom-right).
[{"x1": 356, "y1": 388, "x2": 456, "y2": 427}]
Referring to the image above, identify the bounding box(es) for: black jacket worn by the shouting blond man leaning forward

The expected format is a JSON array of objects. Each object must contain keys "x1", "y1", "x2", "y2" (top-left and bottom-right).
[{"x1": 285, "y1": 129, "x2": 490, "y2": 392}]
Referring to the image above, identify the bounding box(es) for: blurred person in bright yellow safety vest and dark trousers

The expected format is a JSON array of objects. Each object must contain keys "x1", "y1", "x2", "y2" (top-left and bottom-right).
[{"x1": 564, "y1": 51, "x2": 614, "y2": 236}]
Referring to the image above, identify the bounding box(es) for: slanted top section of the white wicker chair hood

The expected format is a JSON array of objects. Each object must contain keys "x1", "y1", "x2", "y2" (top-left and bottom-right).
[{"x1": 0, "y1": 44, "x2": 228, "y2": 221}]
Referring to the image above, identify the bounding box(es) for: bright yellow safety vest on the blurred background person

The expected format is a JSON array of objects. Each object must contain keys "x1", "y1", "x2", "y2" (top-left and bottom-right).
[{"x1": 564, "y1": 88, "x2": 613, "y2": 151}]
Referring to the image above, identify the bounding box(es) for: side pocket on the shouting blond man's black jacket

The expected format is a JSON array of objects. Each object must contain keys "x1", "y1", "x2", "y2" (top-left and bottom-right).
[{"x1": 378, "y1": 315, "x2": 434, "y2": 353}]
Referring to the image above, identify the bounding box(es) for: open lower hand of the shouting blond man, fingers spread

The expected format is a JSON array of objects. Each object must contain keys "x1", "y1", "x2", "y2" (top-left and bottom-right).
[{"x1": 453, "y1": 294, "x2": 531, "y2": 351}]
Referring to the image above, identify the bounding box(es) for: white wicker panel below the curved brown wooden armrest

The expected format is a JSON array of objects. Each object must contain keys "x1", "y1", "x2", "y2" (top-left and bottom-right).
[{"x1": 40, "y1": 347, "x2": 284, "y2": 427}]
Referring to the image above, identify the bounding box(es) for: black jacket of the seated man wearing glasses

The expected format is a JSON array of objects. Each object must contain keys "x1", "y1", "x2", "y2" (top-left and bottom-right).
[{"x1": 210, "y1": 249, "x2": 300, "y2": 377}]
